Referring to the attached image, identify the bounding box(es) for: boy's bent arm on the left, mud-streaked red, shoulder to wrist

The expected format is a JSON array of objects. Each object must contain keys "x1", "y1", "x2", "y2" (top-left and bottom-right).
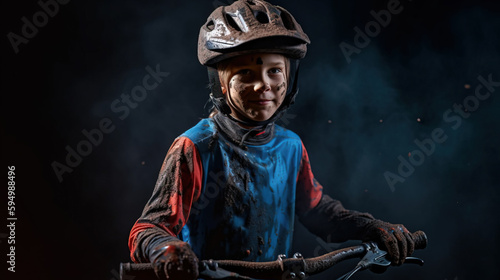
[{"x1": 129, "y1": 137, "x2": 203, "y2": 278}]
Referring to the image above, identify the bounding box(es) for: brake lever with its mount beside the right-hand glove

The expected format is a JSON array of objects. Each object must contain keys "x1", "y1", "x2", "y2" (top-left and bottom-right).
[{"x1": 337, "y1": 242, "x2": 424, "y2": 280}]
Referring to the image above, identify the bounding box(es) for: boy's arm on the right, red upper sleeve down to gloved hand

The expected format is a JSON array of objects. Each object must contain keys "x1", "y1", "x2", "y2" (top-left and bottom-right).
[{"x1": 296, "y1": 142, "x2": 414, "y2": 264}]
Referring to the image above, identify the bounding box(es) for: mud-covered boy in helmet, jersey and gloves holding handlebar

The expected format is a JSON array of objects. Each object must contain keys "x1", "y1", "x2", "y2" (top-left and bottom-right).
[{"x1": 129, "y1": 0, "x2": 414, "y2": 279}]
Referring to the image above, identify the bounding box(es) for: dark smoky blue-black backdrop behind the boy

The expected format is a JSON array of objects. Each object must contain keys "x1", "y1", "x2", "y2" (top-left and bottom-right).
[{"x1": 0, "y1": 0, "x2": 500, "y2": 280}]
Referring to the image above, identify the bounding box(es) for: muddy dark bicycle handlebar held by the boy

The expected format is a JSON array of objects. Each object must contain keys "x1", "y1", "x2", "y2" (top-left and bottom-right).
[{"x1": 120, "y1": 231, "x2": 427, "y2": 280}]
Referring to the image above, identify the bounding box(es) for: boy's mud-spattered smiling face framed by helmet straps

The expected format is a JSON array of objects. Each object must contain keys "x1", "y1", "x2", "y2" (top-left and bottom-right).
[{"x1": 222, "y1": 54, "x2": 287, "y2": 121}]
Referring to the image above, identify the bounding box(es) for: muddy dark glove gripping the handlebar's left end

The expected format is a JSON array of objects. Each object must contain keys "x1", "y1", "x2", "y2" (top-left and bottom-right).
[{"x1": 150, "y1": 240, "x2": 198, "y2": 280}]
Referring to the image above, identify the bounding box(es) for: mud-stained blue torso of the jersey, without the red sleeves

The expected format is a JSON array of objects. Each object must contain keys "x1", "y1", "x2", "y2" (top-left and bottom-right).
[{"x1": 181, "y1": 119, "x2": 302, "y2": 261}]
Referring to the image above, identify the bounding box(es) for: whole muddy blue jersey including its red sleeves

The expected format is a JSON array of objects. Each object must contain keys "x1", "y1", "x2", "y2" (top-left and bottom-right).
[{"x1": 129, "y1": 116, "x2": 322, "y2": 262}]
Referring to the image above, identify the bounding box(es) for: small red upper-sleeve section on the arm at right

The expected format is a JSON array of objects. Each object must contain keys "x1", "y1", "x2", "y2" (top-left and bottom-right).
[{"x1": 295, "y1": 143, "x2": 323, "y2": 214}]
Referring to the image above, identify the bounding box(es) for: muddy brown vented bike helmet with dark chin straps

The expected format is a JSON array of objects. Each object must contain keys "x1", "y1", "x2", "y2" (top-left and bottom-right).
[{"x1": 198, "y1": 0, "x2": 310, "y2": 125}]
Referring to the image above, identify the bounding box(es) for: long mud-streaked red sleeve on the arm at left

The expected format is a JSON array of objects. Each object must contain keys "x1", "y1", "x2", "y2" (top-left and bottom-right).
[{"x1": 128, "y1": 137, "x2": 203, "y2": 261}]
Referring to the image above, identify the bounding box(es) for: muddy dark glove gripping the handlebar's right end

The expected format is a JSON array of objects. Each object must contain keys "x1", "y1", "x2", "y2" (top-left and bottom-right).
[{"x1": 362, "y1": 220, "x2": 415, "y2": 265}]
